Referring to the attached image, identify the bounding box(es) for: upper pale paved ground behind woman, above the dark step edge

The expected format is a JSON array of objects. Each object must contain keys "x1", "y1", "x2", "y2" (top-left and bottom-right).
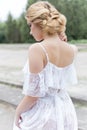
[{"x1": 0, "y1": 44, "x2": 87, "y2": 100}]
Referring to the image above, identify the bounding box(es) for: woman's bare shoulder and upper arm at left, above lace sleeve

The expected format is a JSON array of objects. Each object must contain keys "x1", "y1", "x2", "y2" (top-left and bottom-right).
[{"x1": 28, "y1": 43, "x2": 43, "y2": 73}]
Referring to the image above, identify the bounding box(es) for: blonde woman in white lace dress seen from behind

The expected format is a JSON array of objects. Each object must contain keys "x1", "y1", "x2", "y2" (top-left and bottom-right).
[{"x1": 13, "y1": 1, "x2": 78, "y2": 130}]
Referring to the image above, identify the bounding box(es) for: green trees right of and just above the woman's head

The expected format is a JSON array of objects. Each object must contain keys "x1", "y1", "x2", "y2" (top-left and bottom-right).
[{"x1": 27, "y1": 0, "x2": 87, "y2": 40}]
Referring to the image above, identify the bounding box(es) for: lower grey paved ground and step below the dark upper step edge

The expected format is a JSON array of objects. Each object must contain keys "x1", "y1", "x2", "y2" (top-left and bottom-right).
[{"x1": 0, "y1": 84, "x2": 87, "y2": 130}]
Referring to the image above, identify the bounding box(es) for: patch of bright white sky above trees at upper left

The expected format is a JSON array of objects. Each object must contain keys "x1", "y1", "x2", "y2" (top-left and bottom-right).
[{"x1": 0, "y1": 0, "x2": 27, "y2": 21}]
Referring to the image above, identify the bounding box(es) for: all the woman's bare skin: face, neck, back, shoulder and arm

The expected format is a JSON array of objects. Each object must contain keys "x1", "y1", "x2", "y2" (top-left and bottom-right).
[{"x1": 15, "y1": 23, "x2": 77, "y2": 128}]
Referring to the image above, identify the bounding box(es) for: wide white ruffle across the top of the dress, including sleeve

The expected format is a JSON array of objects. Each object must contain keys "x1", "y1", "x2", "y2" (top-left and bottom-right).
[{"x1": 23, "y1": 63, "x2": 77, "y2": 97}]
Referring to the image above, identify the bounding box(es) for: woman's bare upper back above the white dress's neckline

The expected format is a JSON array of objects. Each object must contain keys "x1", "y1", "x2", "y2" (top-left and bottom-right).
[{"x1": 42, "y1": 37, "x2": 77, "y2": 67}]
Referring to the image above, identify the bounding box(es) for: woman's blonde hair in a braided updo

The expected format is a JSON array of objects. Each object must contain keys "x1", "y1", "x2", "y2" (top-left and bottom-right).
[{"x1": 26, "y1": 1, "x2": 66, "y2": 35}]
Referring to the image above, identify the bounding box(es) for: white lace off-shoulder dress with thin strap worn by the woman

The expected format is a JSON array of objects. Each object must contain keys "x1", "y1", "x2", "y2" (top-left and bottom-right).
[{"x1": 13, "y1": 45, "x2": 78, "y2": 130}]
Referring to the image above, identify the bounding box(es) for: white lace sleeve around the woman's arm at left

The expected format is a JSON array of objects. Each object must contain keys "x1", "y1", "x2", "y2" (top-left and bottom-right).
[{"x1": 22, "y1": 73, "x2": 45, "y2": 97}]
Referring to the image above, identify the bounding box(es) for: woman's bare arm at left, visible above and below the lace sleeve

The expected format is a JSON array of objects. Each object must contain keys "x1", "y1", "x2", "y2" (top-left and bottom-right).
[{"x1": 15, "y1": 45, "x2": 43, "y2": 127}]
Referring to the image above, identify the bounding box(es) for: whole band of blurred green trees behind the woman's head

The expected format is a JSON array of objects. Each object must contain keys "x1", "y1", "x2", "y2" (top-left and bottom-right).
[{"x1": 0, "y1": 0, "x2": 87, "y2": 43}]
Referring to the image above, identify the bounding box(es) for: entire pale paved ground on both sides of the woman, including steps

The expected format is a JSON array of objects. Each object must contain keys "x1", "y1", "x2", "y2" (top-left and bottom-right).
[{"x1": 0, "y1": 44, "x2": 87, "y2": 130}]
